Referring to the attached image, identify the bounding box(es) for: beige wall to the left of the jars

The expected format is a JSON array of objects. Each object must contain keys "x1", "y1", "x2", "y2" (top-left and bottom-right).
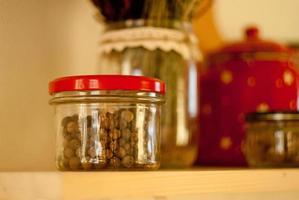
[{"x1": 0, "y1": 0, "x2": 101, "y2": 170}]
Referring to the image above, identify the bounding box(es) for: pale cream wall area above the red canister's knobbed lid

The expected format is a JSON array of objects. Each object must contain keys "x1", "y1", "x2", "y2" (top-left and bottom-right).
[{"x1": 214, "y1": 0, "x2": 299, "y2": 42}]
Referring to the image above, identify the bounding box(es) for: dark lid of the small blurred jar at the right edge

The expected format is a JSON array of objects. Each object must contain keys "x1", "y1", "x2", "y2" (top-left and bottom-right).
[{"x1": 246, "y1": 111, "x2": 299, "y2": 122}]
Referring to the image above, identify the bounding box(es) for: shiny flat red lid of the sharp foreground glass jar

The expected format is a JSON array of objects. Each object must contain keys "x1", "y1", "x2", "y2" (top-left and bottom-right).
[{"x1": 49, "y1": 75, "x2": 165, "y2": 95}]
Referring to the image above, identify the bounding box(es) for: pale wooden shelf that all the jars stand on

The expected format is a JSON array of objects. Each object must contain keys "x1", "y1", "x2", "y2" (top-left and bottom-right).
[{"x1": 0, "y1": 169, "x2": 299, "y2": 200}]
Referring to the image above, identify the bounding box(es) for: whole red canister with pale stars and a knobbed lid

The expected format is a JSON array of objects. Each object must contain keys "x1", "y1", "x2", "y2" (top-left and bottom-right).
[{"x1": 198, "y1": 27, "x2": 299, "y2": 166}]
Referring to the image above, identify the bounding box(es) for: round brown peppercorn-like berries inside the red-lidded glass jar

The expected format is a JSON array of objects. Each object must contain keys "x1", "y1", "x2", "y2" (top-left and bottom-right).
[{"x1": 57, "y1": 106, "x2": 159, "y2": 170}]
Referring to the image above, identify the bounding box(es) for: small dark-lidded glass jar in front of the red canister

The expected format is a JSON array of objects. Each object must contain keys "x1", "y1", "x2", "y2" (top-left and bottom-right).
[{"x1": 245, "y1": 112, "x2": 299, "y2": 167}]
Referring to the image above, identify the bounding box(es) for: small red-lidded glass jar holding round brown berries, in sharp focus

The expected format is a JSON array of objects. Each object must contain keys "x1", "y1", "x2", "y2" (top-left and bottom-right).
[{"x1": 49, "y1": 75, "x2": 165, "y2": 171}]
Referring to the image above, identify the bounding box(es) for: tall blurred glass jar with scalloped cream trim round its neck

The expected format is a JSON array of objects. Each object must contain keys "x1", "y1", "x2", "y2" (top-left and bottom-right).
[{"x1": 98, "y1": 20, "x2": 200, "y2": 167}]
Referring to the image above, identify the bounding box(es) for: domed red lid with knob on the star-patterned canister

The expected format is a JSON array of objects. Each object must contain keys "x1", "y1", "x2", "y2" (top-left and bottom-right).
[{"x1": 219, "y1": 27, "x2": 289, "y2": 53}]
